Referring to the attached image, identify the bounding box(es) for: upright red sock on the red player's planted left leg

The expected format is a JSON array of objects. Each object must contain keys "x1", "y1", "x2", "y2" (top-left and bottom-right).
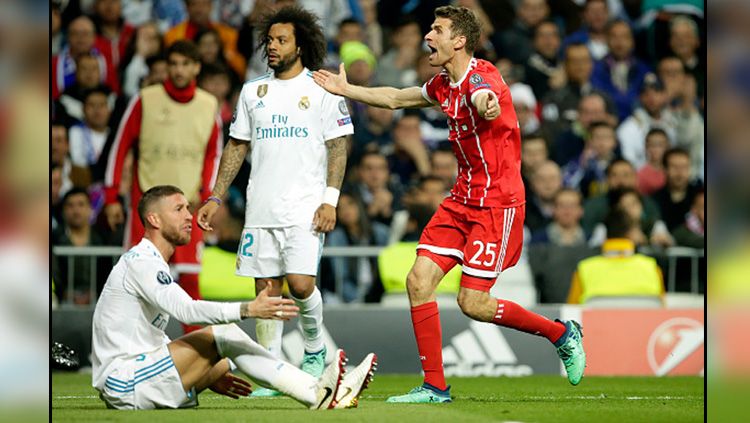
[{"x1": 411, "y1": 301, "x2": 447, "y2": 390}]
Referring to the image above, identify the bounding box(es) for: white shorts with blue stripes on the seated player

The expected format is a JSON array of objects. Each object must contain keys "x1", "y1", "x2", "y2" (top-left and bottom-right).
[{"x1": 99, "y1": 344, "x2": 198, "y2": 410}]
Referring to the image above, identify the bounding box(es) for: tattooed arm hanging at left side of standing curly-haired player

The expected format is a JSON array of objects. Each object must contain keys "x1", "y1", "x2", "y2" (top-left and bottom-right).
[{"x1": 196, "y1": 138, "x2": 250, "y2": 231}]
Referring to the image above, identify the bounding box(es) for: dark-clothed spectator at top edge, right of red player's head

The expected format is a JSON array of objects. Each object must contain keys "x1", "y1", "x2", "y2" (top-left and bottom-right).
[{"x1": 499, "y1": 0, "x2": 549, "y2": 64}]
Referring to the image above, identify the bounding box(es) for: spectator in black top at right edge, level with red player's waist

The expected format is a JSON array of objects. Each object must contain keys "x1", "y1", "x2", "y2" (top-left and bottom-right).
[{"x1": 654, "y1": 147, "x2": 702, "y2": 231}]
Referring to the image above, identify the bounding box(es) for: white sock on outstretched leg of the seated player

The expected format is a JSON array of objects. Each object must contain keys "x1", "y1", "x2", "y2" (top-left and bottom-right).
[{"x1": 212, "y1": 323, "x2": 318, "y2": 407}]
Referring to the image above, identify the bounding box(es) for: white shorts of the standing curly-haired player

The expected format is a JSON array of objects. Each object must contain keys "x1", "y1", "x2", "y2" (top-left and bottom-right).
[{"x1": 235, "y1": 226, "x2": 325, "y2": 278}]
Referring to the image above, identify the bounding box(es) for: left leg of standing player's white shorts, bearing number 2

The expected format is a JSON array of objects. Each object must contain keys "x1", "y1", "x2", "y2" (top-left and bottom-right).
[{"x1": 236, "y1": 228, "x2": 284, "y2": 280}]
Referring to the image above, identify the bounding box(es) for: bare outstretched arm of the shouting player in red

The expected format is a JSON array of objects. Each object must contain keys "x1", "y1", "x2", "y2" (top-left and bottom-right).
[{"x1": 313, "y1": 63, "x2": 432, "y2": 109}]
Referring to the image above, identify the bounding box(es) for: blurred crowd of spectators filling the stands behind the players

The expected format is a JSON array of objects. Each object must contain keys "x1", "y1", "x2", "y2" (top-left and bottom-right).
[{"x1": 50, "y1": 0, "x2": 708, "y2": 303}]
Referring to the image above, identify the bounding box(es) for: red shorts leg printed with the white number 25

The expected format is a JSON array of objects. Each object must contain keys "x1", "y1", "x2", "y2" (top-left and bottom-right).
[{"x1": 461, "y1": 206, "x2": 524, "y2": 291}]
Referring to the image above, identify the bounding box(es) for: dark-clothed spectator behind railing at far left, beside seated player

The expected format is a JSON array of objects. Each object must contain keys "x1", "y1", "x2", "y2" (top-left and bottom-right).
[{"x1": 52, "y1": 188, "x2": 104, "y2": 304}]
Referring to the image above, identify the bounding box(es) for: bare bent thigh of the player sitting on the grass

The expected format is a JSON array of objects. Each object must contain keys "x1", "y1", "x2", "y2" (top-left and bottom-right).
[{"x1": 168, "y1": 327, "x2": 220, "y2": 391}]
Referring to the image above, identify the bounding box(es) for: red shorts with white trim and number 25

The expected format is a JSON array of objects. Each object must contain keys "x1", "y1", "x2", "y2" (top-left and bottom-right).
[{"x1": 417, "y1": 199, "x2": 526, "y2": 291}]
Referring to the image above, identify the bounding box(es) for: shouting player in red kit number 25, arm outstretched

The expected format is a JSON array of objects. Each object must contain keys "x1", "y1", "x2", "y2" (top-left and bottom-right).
[{"x1": 313, "y1": 6, "x2": 586, "y2": 403}]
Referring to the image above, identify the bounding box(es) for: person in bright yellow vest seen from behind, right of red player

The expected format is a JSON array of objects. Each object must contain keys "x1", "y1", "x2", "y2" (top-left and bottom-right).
[{"x1": 568, "y1": 210, "x2": 664, "y2": 304}]
